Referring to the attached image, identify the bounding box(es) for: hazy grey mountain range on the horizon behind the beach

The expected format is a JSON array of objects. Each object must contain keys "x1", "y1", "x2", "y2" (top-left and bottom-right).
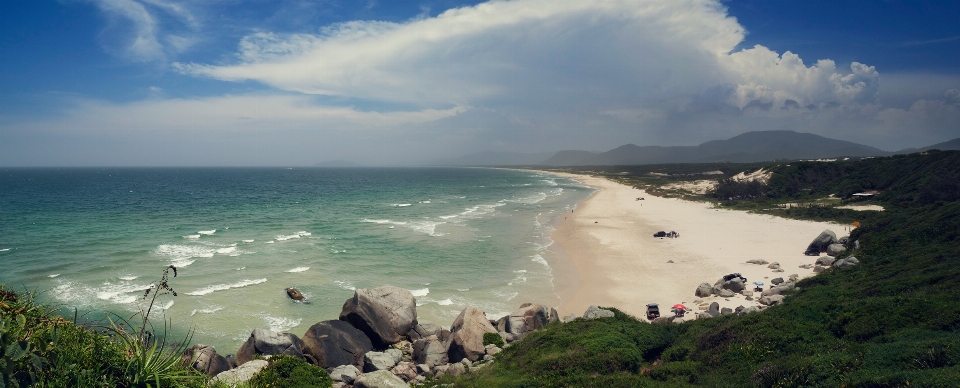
[{"x1": 435, "y1": 131, "x2": 960, "y2": 166}]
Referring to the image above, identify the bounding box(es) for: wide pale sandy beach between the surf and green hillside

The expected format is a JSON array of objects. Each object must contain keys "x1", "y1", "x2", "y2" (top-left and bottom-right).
[{"x1": 551, "y1": 174, "x2": 846, "y2": 318}]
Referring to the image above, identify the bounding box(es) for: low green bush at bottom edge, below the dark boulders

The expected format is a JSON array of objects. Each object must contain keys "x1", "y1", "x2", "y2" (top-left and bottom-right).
[{"x1": 250, "y1": 356, "x2": 333, "y2": 388}]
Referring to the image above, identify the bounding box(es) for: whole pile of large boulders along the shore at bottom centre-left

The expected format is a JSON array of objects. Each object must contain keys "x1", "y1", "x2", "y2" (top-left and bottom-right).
[{"x1": 183, "y1": 286, "x2": 614, "y2": 388}]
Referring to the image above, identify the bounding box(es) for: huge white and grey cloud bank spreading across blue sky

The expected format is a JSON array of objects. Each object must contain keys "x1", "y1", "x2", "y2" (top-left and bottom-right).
[{"x1": 0, "y1": 0, "x2": 960, "y2": 164}]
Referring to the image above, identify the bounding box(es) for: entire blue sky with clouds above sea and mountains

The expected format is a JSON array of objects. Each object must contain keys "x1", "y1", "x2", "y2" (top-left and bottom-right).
[{"x1": 0, "y1": 0, "x2": 960, "y2": 166}]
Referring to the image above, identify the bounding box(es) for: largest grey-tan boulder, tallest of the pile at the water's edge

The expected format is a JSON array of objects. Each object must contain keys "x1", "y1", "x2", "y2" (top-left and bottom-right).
[{"x1": 340, "y1": 286, "x2": 417, "y2": 349}]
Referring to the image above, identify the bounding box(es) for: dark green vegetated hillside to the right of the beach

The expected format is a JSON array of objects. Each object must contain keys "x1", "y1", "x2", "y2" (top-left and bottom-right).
[{"x1": 432, "y1": 152, "x2": 960, "y2": 387}]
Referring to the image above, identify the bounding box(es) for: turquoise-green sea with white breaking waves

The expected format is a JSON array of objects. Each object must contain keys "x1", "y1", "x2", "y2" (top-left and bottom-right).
[{"x1": 0, "y1": 168, "x2": 592, "y2": 353}]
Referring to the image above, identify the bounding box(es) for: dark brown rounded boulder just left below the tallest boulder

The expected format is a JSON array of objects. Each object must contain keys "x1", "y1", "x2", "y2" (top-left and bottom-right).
[{"x1": 303, "y1": 320, "x2": 373, "y2": 370}]
